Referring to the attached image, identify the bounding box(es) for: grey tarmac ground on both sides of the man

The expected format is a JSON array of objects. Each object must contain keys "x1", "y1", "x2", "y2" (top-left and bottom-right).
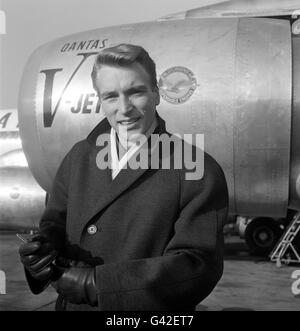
[{"x1": 0, "y1": 232, "x2": 300, "y2": 311}]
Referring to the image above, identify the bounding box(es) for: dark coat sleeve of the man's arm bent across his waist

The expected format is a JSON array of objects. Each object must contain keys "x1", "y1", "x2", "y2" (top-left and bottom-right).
[{"x1": 96, "y1": 156, "x2": 228, "y2": 310}]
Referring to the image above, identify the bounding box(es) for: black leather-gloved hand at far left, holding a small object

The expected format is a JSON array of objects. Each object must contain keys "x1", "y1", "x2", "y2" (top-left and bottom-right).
[{"x1": 19, "y1": 234, "x2": 57, "y2": 281}]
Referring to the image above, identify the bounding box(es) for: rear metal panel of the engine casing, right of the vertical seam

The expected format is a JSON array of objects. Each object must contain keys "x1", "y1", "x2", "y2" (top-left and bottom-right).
[{"x1": 233, "y1": 19, "x2": 292, "y2": 216}]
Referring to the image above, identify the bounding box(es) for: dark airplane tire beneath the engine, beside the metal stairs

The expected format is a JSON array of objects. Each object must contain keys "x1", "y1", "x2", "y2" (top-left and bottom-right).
[{"x1": 245, "y1": 218, "x2": 282, "y2": 256}]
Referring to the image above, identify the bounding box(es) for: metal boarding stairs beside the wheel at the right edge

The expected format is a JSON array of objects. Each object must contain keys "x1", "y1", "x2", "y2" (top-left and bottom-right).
[{"x1": 270, "y1": 212, "x2": 300, "y2": 267}]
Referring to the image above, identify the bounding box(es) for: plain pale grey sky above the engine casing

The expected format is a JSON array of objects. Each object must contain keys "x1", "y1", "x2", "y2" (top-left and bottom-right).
[{"x1": 0, "y1": 0, "x2": 212, "y2": 109}]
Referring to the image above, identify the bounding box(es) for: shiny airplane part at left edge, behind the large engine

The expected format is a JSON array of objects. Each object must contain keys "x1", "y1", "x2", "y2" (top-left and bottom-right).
[{"x1": 0, "y1": 109, "x2": 46, "y2": 231}]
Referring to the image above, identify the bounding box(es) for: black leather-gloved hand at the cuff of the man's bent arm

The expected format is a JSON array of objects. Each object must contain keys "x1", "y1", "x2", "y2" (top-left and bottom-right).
[{"x1": 52, "y1": 265, "x2": 98, "y2": 307}]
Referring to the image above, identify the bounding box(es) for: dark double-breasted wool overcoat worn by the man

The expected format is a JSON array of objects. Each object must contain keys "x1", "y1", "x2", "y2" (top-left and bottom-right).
[{"x1": 31, "y1": 119, "x2": 228, "y2": 310}]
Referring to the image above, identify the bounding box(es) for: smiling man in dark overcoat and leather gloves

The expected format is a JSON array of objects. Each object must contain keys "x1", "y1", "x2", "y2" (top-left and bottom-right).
[{"x1": 20, "y1": 44, "x2": 228, "y2": 310}]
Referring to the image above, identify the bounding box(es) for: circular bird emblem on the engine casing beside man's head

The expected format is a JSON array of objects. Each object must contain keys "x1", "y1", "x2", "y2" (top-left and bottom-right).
[{"x1": 158, "y1": 67, "x2": 197, "y2": 104}]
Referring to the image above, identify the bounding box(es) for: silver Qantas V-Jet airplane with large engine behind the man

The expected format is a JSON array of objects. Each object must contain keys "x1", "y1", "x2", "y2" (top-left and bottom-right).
[{"x1": 14, "y1": 0, "x2": 300, "y2": 254}]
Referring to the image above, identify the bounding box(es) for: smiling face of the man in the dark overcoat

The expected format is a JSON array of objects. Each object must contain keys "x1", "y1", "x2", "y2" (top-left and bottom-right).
[{"x1": 96, "y1": 62, "x2": 159, "y2": 140}]
